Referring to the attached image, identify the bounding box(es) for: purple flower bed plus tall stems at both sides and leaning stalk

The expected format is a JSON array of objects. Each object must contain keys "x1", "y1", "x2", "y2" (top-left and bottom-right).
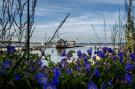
[{"x1": 0, "y1": 0, "x2": 135, "y2": 89}]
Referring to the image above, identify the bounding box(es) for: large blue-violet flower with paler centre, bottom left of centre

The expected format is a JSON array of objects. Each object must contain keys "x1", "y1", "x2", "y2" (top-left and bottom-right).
[{"x1": 35, "y1": 72, "x2": 48, "y2": 86}]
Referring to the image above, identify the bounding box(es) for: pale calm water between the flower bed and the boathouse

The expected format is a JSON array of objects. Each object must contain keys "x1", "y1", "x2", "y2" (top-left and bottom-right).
[{"x1": 32, "y1": 46, "x2": 112, "y2": 65}]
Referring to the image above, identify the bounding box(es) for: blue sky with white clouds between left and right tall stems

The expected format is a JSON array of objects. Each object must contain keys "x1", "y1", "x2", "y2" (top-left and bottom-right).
[{"x1": 0, "y1": 0, "x2": 131, "y2": 43}]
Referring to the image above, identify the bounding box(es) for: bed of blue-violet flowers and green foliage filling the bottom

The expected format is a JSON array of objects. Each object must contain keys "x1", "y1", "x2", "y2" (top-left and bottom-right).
[{"x1": 0, "y1": 46, "x2": 135, "y2": 89}]
